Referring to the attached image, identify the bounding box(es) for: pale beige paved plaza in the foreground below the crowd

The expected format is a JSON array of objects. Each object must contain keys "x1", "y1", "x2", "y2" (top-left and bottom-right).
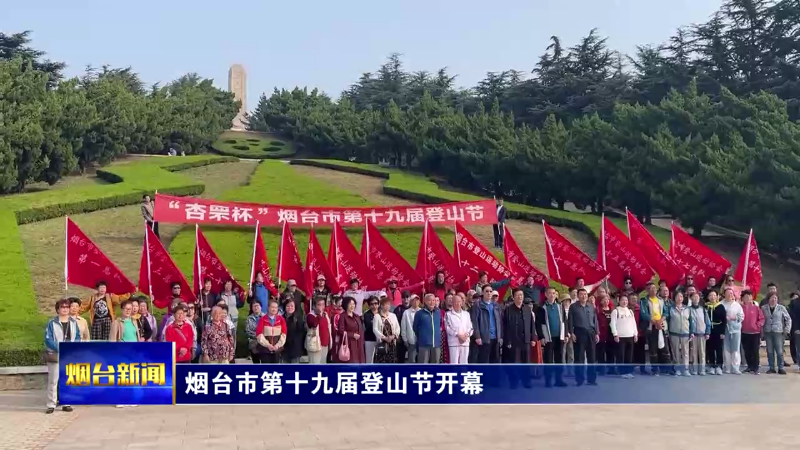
[{"x1": 0, "y1": 374, "x2": 800, "y2": 450}]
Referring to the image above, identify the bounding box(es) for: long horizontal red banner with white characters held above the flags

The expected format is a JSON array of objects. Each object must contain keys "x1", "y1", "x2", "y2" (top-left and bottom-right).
[{"x1": 153, "y1": 194, "x2": 497, "y2": 227}]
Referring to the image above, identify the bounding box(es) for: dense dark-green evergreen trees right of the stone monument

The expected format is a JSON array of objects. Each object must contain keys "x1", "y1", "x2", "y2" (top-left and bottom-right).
[{"x1": 248, "y1": 0, "x2": 800, "y2": 255}]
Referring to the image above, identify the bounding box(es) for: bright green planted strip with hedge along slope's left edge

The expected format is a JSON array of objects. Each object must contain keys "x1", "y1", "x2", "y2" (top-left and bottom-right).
[{"x1": 0, "y1": 155, "x2": 236, "y2": 366}]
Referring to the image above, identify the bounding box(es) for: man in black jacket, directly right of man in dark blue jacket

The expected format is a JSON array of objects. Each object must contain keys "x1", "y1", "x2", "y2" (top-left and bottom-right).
[{"x1": 502, "y1": 288, "x2": 539, "y2": 389}]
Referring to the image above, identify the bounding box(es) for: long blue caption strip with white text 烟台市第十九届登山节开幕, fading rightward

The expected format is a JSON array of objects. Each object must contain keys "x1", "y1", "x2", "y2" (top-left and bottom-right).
[{"x1": 175, "y1": 364, "x2": 800, "y2": 404}]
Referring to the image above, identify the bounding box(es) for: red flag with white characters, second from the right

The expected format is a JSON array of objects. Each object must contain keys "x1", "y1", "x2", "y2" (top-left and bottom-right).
[{"x1": 669, "y1": 223, "x2": 731, "y2": 286}]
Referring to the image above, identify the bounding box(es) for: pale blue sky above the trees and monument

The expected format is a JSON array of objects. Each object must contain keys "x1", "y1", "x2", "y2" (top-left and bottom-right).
[{"x1": 6, "y1": 0, "x2": 721, "y2": 109}]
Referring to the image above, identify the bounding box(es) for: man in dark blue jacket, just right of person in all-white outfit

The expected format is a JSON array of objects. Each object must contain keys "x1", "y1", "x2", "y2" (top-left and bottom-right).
[{"x1": 470, "y1": 285, "x2": 503, "y2": 364}]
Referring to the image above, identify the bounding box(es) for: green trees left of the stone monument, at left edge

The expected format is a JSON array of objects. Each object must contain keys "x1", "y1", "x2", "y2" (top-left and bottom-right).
[{"x1": 0, "y1": 31, "x2": 239, "y2": 193}]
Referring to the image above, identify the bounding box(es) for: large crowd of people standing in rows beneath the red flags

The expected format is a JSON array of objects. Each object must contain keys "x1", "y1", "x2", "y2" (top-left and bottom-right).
[{"x1": 45, "y1": 272, "x2": 800, "y2": 413}]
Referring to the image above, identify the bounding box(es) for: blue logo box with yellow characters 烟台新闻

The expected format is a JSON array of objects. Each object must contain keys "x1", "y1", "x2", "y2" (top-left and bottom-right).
[{"x1": 58, "y1": 342, "x2": 175, "y2": 405}]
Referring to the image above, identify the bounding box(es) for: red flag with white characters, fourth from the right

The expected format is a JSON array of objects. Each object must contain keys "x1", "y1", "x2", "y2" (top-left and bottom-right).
[{"x1": 597, "y1": 214, "x2": 654, "y2": 291}]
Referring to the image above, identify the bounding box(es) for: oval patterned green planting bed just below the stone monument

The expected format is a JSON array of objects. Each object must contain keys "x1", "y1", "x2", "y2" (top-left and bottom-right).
[{"x1": 213, "y1": 131, "x2": 295, "y2": 159}]
